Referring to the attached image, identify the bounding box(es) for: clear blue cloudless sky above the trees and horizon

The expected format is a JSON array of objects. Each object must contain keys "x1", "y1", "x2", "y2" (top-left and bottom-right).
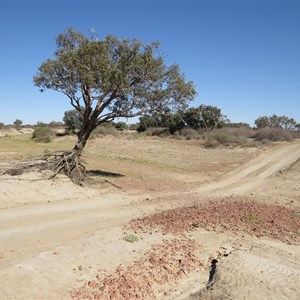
[{"x1": 0, "y1": 0, "x2": 300, "y2": 125}]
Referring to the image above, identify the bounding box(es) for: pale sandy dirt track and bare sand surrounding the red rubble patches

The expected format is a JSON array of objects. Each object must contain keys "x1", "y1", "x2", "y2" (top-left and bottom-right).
[{"x1": 0, "y1": 141, "x2": 300, "y2": 300}]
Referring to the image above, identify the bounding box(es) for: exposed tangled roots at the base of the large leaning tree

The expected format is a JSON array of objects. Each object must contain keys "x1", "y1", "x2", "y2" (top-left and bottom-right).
[{"x1": 2, "y1": 151, "x2": 85, "y2": 185}]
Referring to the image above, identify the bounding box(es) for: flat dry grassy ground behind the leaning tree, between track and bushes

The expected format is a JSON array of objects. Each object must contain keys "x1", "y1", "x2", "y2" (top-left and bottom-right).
[{"x1": 0, "y1": 132, "x2": 259, "y2": 189}]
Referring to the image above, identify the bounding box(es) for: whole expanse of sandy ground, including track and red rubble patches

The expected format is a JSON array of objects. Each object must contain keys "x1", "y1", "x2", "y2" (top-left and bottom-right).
[{"x1": 0, "y1": 137, "x2": 300, "y2": 300}]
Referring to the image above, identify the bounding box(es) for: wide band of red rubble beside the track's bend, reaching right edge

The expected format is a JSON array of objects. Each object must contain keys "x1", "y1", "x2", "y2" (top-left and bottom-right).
[{"x1": 129, "y1": 200, "x2": 300, "y2": 244}]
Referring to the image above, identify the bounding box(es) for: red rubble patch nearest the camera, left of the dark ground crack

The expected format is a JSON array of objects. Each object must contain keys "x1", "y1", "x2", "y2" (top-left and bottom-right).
[{"x1": 71, "y1": 238, "x2": 202, "y2": 300}]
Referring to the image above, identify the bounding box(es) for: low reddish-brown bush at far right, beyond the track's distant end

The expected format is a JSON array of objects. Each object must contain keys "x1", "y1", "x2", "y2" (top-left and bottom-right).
[{"x1": 253, "y1": 127, "x2": 293, "y2": 141}]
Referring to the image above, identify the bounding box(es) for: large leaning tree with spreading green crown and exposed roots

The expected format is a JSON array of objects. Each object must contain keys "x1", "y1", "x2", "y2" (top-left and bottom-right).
[{"x1": 33, "y1": 28, "x2": 196, "y2": 181}]
